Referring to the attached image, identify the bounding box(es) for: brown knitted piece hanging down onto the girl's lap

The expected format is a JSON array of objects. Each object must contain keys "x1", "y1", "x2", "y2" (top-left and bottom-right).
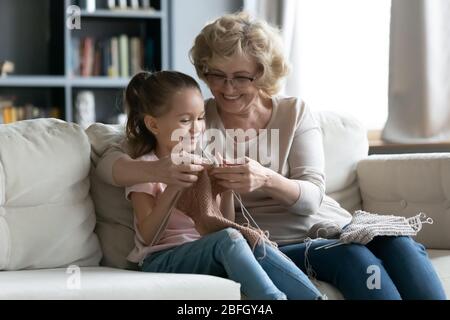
[{"x1": 176, "y1": 170, "x2": 276, "y2": 249}]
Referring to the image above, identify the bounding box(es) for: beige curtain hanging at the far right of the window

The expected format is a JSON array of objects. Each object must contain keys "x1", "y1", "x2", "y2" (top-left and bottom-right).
[{"x1": 383, "y1": 0, "x2": 450, "y2": 143}]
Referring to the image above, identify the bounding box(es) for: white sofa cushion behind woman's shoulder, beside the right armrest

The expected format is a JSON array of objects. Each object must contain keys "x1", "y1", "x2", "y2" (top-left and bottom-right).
[{"x1": 314, "y1": 111, "x2": 369, "y2": 213}]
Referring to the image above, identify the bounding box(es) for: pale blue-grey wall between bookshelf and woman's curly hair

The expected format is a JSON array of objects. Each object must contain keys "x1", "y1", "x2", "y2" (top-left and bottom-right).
[{"x1": 170, "y1": 0, "x2": 243, "y2": 97}]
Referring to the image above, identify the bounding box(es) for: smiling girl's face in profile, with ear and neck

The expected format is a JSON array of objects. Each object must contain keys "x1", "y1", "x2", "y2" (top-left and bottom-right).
[{"x1": 146, "y1": 88, "x2": 205, "y2": 156}]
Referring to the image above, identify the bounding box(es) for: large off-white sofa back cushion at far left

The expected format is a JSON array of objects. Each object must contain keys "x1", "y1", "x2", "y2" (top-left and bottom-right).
[{"x1": 0, "y1": 119, "x2": 101, "y2": 270}]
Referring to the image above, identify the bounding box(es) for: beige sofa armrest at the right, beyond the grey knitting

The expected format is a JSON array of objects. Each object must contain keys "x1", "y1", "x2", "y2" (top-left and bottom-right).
[{"x1": 357, "y1": 153, "x2": 450, "y2": 249}]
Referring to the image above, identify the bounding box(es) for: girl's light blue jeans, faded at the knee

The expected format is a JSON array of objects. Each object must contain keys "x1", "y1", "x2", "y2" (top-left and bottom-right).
[{"x1": 142, "y1": 228, "x2": 322, "y2": 300}]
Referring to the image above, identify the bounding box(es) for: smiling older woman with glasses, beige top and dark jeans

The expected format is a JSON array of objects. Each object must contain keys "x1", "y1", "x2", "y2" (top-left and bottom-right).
[{"x1": 96, "y1": 13, "x2": 445, "y2": 299}]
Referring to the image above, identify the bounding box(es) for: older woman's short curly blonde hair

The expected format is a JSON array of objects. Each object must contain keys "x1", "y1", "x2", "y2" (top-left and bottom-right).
[{"x1": 189, "y1": 12, "x2": 290, "y2": 96}]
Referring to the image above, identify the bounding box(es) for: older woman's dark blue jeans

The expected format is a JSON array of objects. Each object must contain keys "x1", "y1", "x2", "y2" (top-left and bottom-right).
[{"x1": 280, "y1": 236, "x2": 446, "y2": 300}]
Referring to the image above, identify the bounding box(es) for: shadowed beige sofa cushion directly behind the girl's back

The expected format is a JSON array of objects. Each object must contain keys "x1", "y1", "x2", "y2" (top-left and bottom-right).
[{"x1": 86, "y1": 123, "x2": 137, "y2": 269}]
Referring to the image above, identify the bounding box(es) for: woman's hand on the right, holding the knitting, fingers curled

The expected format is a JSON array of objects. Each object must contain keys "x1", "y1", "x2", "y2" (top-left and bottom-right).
[{"x1": 211, "y1": 157, "x2": 272, "y2": 193}]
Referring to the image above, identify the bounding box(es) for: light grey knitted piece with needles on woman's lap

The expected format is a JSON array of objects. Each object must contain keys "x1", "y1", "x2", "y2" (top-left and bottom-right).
[{"x1": 339, "y1": 210, "x2": 433, "y2": 244}]
